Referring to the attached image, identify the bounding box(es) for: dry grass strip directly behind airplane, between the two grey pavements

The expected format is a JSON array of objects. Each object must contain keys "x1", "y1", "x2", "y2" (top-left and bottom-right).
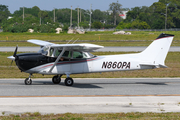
[{"x1": 0, "y1": 52, "x2": 180, "y2": 79}]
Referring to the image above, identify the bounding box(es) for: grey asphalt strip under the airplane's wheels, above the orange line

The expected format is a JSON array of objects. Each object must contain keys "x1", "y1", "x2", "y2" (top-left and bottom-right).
[{"x1": 0, "y1": 76, "x2": 180, "y2": 96}]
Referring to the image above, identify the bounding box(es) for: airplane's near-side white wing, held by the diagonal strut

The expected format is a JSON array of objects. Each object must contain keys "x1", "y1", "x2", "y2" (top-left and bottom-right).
[{"x1": 51, "y1": 43, "x2": 104, "y2": 52}]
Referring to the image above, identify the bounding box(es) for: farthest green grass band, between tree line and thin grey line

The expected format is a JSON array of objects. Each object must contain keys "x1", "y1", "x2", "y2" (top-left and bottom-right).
[{"x1": 0, "y1": 31, "x2": 180, "y2": 41}]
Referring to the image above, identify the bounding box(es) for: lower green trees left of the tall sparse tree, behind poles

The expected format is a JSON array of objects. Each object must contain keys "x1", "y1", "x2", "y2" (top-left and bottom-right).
[{"x1": 0, "y1": 5, "x2": 120, "y2": 33}]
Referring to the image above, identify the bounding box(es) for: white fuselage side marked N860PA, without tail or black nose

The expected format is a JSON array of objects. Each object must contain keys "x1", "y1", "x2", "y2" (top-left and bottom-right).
[{"x1": 26, "y1": 54, "x2": 153, "y2": 74}]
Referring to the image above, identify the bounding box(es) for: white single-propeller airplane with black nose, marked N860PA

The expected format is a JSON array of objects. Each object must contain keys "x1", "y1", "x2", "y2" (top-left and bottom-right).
[{"x1": 8, "y1": 33, "x2": 174, "y2": 86}]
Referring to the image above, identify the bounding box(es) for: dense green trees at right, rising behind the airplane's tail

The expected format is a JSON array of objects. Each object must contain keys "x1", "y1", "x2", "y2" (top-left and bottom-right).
[{"x1": 117, "y1": 0, "x2": 180, "y2": 29}]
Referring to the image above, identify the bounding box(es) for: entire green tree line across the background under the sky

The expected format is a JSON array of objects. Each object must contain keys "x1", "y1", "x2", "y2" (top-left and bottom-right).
[{"x1": 0, "y1": 0, "x2": 180, "y2": 33}]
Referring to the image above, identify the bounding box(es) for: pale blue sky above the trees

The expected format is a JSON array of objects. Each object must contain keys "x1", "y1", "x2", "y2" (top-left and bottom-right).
[{"x1": 0, "y1": 0, "x2": 159, "y2": 13}]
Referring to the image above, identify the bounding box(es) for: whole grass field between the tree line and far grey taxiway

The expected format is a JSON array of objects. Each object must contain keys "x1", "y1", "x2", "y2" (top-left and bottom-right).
[{"x1": 0, "y1": 31, "x2": 180, "y2": 46}]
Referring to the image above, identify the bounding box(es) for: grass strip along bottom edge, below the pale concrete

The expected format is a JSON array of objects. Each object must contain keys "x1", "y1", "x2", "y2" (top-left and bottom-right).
[{"x1": 0, "y1": 111, "x2": 180, "y2": 120}]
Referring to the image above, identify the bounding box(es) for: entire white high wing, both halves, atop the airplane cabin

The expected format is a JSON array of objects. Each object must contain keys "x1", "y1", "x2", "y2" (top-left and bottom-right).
[{"x1": 27, "y1": 39, "x2": 104, "y2": 52}]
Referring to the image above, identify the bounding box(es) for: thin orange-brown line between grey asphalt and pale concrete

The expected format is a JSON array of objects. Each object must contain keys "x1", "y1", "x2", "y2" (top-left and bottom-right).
[{"x1": 0, "y1": 94, "x2": 180, "y2": 98}]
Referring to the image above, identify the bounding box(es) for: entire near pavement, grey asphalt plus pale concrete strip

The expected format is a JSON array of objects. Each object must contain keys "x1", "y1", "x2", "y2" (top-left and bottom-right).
[{"x1": 0, "y1": 78, "x2": 180, "y2": 115}]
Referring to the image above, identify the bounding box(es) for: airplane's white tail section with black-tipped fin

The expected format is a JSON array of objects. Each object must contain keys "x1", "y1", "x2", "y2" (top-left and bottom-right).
[{"x1": 139, "y1": 33, "x2": 174, "y2": 67}]
